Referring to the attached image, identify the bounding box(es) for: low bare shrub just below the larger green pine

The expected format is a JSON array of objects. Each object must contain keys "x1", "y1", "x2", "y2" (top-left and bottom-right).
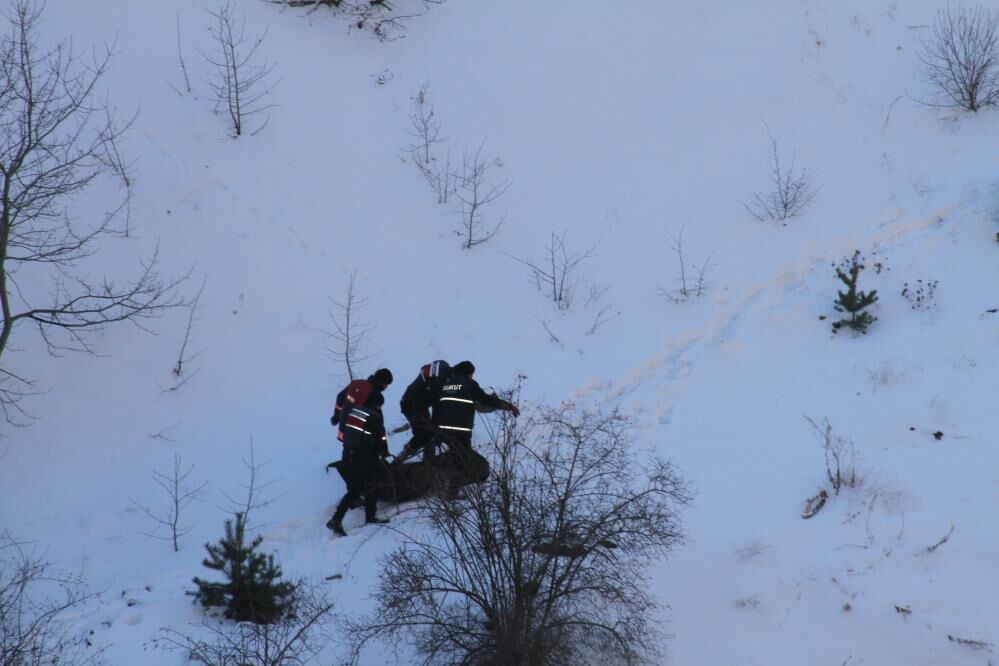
[{"x1": 154, "y1": 581, "x2": 334, "y2": 666}]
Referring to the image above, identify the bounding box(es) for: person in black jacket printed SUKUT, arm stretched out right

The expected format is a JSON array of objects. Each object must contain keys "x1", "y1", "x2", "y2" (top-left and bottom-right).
[{"x1": 431, "y1": 361, "x2": 520, "y2": 452}]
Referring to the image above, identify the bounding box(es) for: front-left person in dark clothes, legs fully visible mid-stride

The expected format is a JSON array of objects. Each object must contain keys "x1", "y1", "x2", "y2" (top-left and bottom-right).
[{"x1": 326, "y1": 391, "x2": 388, "y2": 536}]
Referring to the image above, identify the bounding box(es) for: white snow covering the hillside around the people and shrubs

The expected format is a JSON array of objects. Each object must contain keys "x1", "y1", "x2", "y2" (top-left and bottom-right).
[{"x1": 0, "y1": 0, "x2": 999, "y2": 666}]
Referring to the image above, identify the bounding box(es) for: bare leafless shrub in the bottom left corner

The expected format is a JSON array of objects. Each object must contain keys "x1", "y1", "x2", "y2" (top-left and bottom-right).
[{"x1": 0, "y1": 532, "x2": 104, "y2": 666}]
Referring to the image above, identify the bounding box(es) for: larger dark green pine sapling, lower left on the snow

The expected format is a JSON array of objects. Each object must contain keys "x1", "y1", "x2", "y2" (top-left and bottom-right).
[{"x1": 188, "y1": 513, "x2": 295, "y2": 624}]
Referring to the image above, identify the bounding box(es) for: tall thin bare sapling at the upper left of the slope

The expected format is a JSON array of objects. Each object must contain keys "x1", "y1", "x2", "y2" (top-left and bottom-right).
[{"x1": 201, "y1": 0, "x2": 278, "y2": 137}]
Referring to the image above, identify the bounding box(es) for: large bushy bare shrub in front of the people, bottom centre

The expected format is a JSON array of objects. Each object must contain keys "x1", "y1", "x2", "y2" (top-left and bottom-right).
[{"x1": 350, "y1": 404, "x2": 690, "y2": 666}]
